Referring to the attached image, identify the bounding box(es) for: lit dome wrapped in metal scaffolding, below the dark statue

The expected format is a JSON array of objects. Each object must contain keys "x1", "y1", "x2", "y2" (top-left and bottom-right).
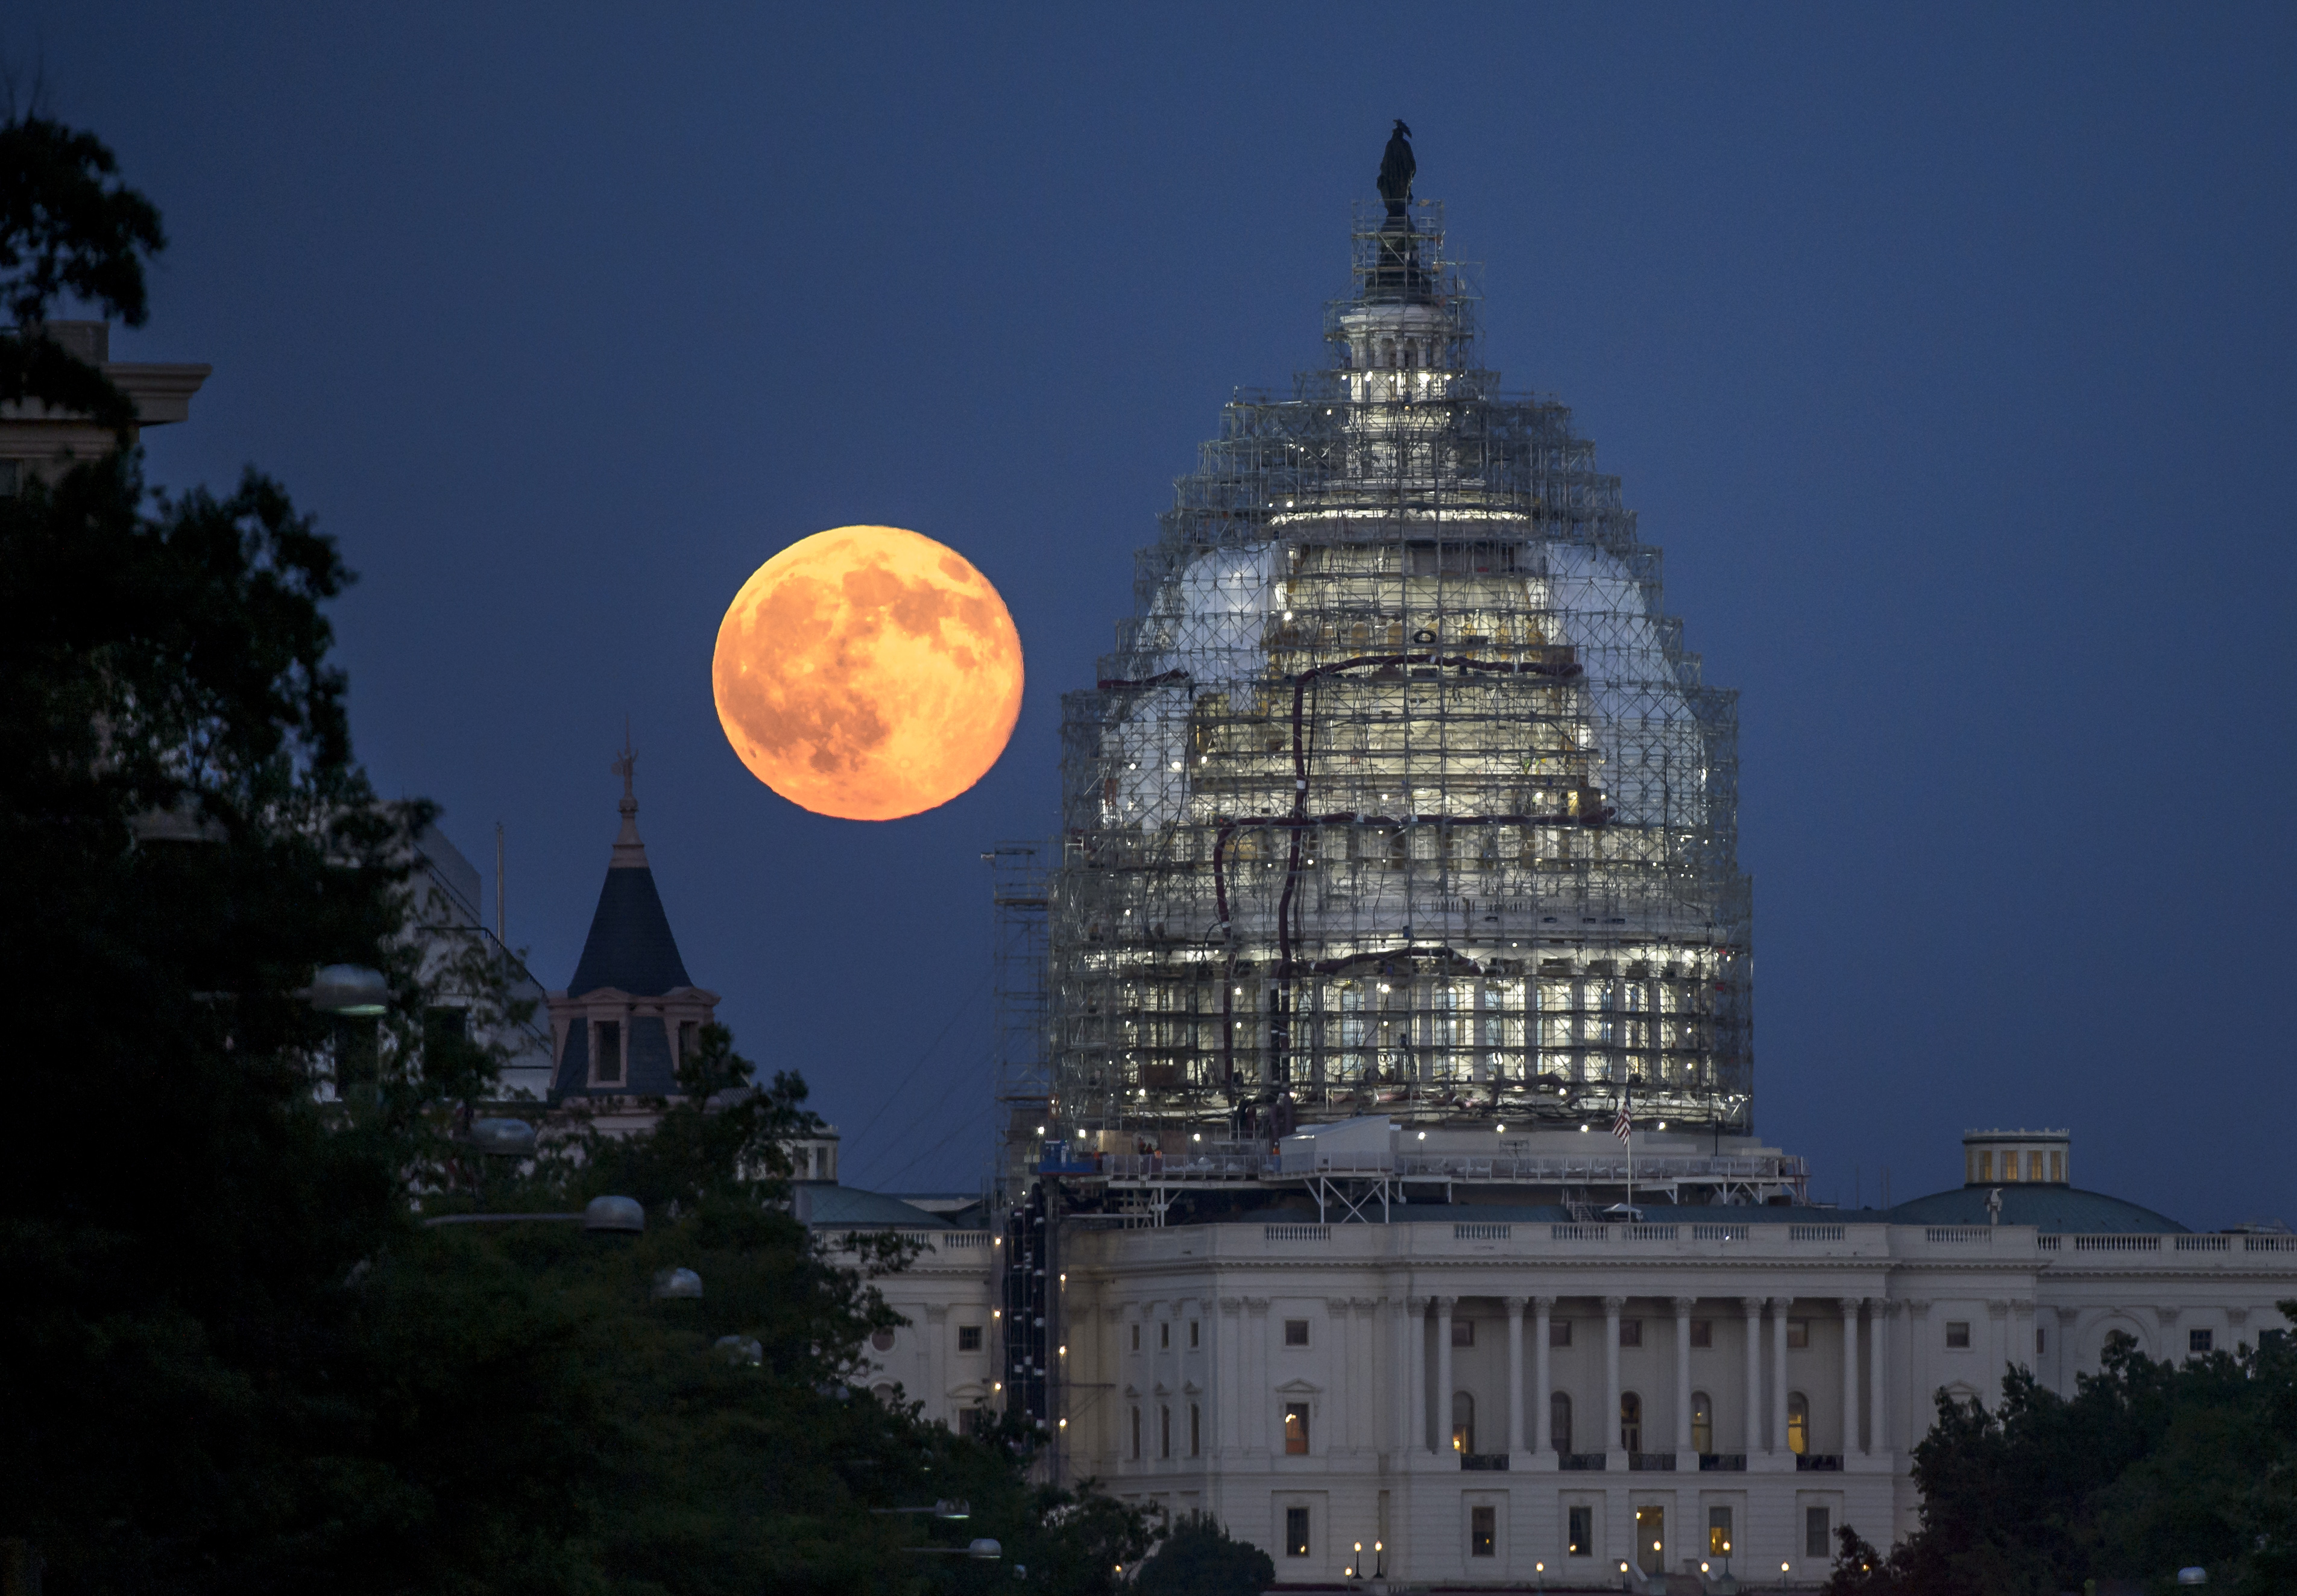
[{"x1": 1045, "y1": 202, "x2": 1753, "y2": 1153}]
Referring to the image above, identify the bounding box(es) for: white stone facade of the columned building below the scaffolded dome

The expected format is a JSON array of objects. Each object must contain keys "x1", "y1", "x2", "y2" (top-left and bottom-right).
[{"x1": 882, "y1": 1208, "x2": 2297, "y2": 1589}]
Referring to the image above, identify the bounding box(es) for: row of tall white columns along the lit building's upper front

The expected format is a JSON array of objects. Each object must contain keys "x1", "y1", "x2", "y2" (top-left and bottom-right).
[{"x1": 1396, "y1": 1295, "x2": 1897, "y2": 1456}]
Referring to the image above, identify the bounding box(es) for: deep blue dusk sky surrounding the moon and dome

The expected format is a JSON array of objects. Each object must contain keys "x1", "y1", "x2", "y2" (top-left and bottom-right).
[{"x1": 22, "y1": 5, "x2": 2297, "y2": 1224}]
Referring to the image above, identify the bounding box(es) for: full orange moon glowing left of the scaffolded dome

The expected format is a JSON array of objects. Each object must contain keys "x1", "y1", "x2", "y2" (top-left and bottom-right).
[{"x1": 710, "y1": 526, "x2": 1022, "y2": 820}]
